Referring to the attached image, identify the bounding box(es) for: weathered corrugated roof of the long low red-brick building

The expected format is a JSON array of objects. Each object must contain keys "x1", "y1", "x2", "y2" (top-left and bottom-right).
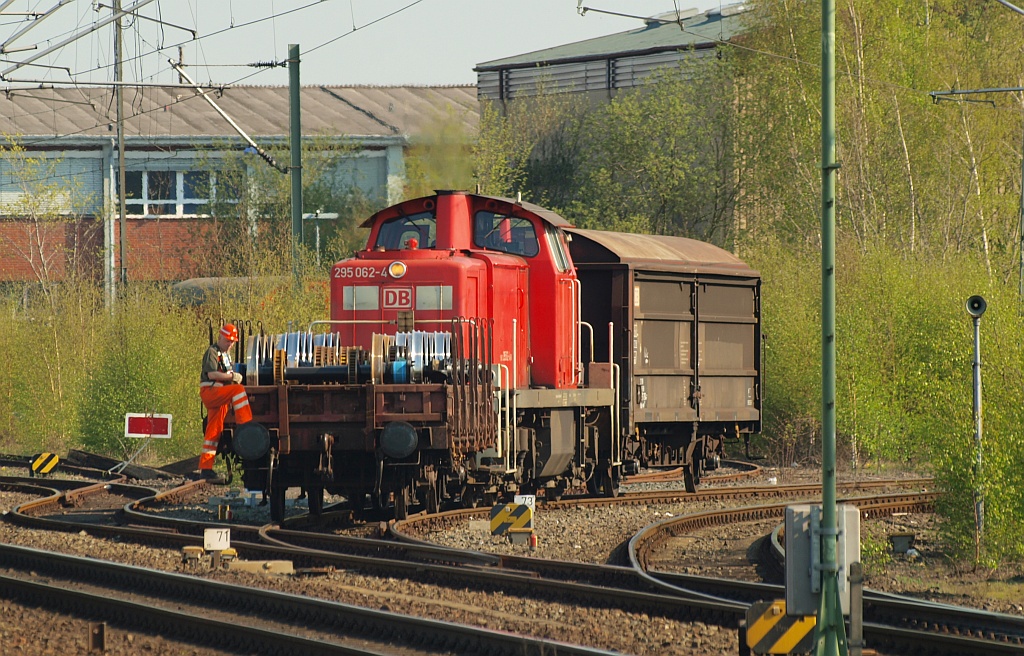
[{"x1": 0, "y1": 86, "x2": 479, "y2": 142}]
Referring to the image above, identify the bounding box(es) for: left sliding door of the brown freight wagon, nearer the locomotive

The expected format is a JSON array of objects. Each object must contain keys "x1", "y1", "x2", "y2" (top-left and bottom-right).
[{"x1": 632, "y1": 272, "x2": 697, "y2": 423}]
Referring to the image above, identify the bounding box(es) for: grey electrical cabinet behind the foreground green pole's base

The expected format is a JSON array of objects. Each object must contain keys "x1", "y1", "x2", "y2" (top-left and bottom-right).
[{"x1": 785, "y1": 504, "x2": 860, "y2": 615}]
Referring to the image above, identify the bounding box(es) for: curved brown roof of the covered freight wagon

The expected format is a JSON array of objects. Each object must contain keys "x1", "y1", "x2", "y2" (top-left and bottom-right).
[{"x1": 565, "y1": 228, "x2": 760, "y2": 277}]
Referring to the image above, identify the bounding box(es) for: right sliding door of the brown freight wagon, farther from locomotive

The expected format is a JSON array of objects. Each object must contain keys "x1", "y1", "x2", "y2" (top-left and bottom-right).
[{"x1": 696, "y1": 279, "x2": 761, "y2": 425}]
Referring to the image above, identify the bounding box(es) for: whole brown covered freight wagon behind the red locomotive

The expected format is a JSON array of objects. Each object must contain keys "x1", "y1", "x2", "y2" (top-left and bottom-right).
[{"x1": 567, "y1": 229, "x2": 762, "y2": 491}]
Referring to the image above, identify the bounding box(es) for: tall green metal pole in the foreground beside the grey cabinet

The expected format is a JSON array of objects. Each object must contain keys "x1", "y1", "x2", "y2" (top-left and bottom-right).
[{"x1": 812, "y1": 0, "x2": 847, "y2": 656}]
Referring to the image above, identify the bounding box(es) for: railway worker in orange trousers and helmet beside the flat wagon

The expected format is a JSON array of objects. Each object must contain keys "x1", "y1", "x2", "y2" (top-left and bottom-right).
[{"x1": 199, "y1": 323, "x2": 253, "y2": 480}]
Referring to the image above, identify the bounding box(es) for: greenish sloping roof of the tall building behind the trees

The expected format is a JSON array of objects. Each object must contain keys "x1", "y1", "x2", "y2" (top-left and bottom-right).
[{"x1": 473, "y1": 4, "x2": 751, "y2": 72}]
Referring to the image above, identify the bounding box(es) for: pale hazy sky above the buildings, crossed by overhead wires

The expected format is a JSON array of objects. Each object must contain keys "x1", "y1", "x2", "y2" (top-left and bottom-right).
[{"x1": 0, "y1": 0, "x2": 720, "y2": 88}]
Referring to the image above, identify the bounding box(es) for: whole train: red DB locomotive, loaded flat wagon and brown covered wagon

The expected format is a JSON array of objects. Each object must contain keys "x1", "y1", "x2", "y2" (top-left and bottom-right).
[{"x1": 222, "y1": 191, "x2": 762, "y2": 521}]
